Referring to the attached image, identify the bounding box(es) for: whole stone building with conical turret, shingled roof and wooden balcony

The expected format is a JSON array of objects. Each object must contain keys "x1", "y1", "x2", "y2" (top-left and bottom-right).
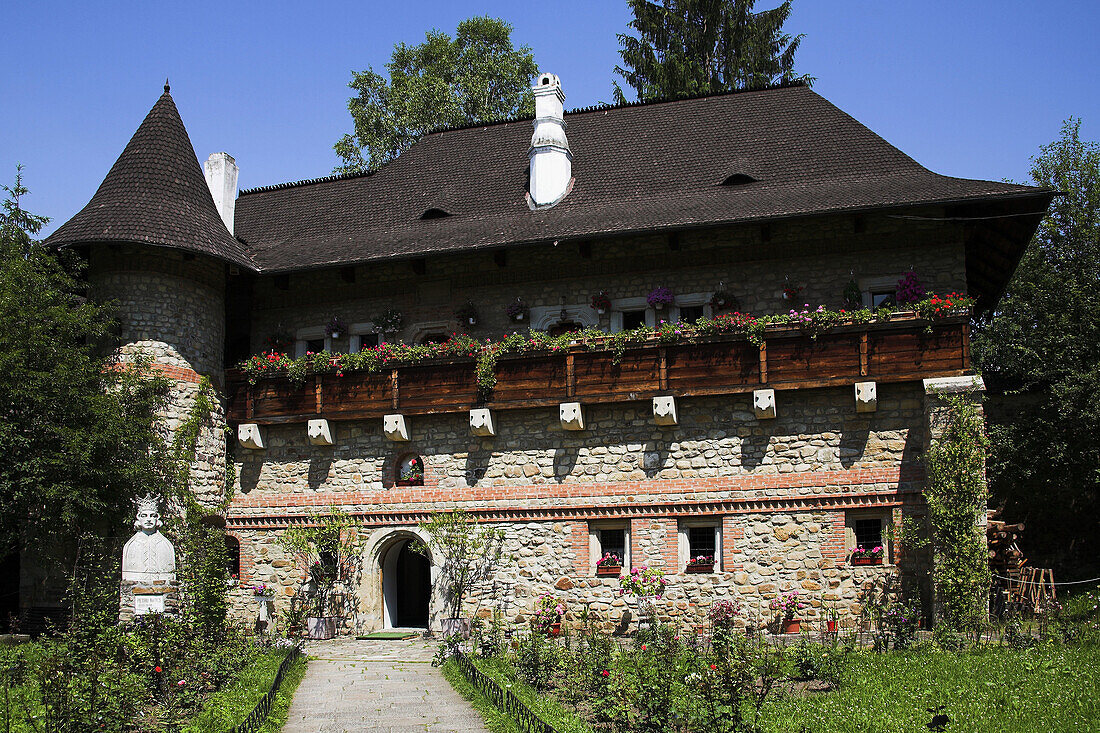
[{"x1": 48, "y1": 74, "x2": 1053, "y2": 630}]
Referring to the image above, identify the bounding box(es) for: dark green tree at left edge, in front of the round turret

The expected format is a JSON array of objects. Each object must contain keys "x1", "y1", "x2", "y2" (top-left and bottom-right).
[{"x1": 0, "y1": 167, "x2": 167, "y2": 553}]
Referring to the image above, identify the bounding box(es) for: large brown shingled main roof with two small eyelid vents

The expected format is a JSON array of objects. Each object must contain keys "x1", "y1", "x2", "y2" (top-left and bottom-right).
[{"x1": 237, "y1": 86, "x2": 1049, "y2": 272}]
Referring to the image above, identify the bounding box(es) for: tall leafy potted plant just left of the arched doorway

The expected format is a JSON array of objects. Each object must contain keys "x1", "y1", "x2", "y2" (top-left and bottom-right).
[{"x1": 278, "y1": 506, "x2": 362, "y2": 638}]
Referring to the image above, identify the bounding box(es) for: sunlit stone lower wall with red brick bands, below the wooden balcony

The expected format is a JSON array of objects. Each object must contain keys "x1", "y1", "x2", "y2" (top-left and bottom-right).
[{"x1": 230, "y1": 384, "x2": 924, "y2": 630}]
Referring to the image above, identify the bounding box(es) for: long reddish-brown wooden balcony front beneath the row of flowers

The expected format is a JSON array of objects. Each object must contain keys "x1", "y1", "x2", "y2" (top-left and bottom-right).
[{"x1": 227, "y1": 316, "x2": 970, "y2": 424}]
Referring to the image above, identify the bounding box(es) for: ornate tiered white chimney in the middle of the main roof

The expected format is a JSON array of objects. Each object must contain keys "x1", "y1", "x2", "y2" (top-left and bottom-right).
[{"x1": 527, "y1": 74, "x2": 573, "y2": 206}]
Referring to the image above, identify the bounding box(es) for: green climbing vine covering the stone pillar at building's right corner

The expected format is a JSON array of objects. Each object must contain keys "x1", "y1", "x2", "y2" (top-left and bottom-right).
[{"x1": 925, "y1": 396, "x2": 990, "y2": 630}]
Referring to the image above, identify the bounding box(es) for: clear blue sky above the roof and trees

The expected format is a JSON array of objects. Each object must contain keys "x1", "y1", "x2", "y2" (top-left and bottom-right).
[{"x1": 0, "y1": 0, "x2": 1100, "y2": 232}]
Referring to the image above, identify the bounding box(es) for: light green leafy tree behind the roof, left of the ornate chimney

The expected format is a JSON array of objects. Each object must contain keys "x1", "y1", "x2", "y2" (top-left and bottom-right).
[{"x1": 334, "y1": 18, "x2": 538, "y2": 173}]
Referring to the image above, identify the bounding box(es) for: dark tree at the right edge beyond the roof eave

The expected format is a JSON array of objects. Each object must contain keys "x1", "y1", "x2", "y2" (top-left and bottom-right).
[{"x1": 975, "y1": 119, "x2": 1100, "y2": 580}]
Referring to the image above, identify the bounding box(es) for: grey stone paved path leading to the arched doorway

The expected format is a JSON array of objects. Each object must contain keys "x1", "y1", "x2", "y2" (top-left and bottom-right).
[{"x1": 283, "y1": 638, "x2": 487, "y2": 733}]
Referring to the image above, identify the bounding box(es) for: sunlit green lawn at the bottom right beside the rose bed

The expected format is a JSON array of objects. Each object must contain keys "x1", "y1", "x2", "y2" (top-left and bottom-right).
[{"x1": 762, "y1": 646, "x2": 1100, "y2": 733}]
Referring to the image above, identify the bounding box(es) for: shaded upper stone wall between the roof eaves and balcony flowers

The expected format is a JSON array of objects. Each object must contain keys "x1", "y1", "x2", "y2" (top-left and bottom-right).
[{"x1": 252, "y1": 210, "x2": 966, "y2": 352}]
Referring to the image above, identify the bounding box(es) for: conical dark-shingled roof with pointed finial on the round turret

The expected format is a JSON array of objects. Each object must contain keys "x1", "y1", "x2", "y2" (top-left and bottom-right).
[{"x1": 46, "y1": 84, "x2": 254, "y2": 267}]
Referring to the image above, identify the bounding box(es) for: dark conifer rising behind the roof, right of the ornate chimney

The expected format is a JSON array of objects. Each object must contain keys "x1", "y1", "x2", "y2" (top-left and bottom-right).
[{"x1": 615, "y1": 0, "x2": 813, "y2": 103}]
